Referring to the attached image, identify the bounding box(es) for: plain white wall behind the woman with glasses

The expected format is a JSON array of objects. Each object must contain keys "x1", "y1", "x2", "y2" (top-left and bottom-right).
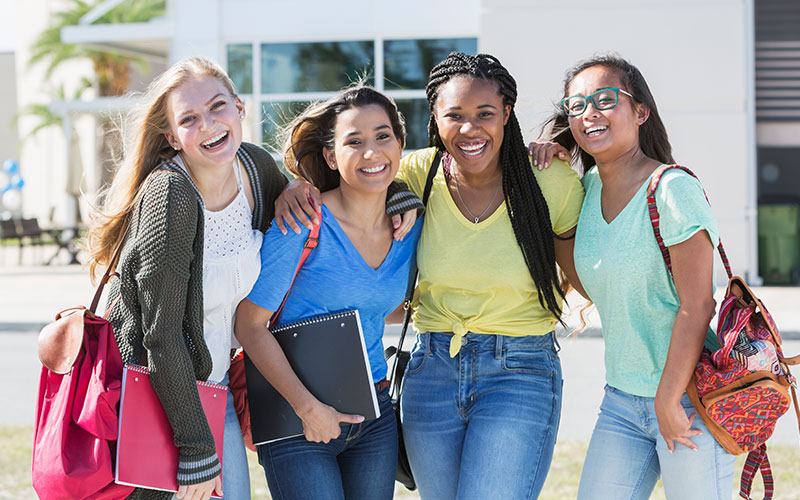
[{"x1": 479, "y1": 0, "x2": 757, "y2": 280}]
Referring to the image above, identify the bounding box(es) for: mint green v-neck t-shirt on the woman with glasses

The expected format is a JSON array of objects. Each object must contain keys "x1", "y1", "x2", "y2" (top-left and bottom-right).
[{"x1": 574, "y1": 166, "x2": 719, "y2": 397}]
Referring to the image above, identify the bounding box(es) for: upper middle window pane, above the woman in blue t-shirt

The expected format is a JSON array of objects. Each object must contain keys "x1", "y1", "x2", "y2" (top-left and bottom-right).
[{"x1": 261, "y1": 41, "x2": 375, "y2": 94}]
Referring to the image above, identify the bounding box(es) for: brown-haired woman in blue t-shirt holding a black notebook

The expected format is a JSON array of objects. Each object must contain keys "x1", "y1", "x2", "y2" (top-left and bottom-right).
[{"x1": 235, "y1": 87, "x2": 422, "y2": 500}]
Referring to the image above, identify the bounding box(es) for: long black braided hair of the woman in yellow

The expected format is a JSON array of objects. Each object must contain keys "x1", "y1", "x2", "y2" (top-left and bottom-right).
[{"x1": 425, "y1": 52, "x2": 564, "y2": 323}]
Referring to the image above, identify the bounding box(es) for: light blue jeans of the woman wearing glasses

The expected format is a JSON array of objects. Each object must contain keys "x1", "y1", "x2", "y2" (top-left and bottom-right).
[{"x1": 578, "y1": 385, "x2": 736, "y2": 500}]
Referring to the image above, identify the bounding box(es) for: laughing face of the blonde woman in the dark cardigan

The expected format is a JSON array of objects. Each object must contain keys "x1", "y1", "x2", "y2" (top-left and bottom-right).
[{"x1": 166, "y1": 76, "x2": 244, "y2": 171}]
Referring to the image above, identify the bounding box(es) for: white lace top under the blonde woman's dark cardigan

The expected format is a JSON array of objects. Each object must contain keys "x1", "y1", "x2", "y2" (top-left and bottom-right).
[{"x1": 175, "y1": 156, "x2": 264, "y2": 382}]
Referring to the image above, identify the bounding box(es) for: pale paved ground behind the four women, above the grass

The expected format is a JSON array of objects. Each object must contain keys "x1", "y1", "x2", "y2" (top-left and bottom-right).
[{"x1": 0, "y1": 262, "x2": 800, "y2": 444}]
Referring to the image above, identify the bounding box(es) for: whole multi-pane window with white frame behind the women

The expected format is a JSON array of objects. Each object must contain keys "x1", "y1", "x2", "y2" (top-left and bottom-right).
[{"x1": 226, "y1": 38, "x2": 478, "y2": 151}]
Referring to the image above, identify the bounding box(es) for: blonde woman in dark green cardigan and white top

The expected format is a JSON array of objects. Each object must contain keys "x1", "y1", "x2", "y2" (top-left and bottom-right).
[{"x1": 88, "y1": 58, "x2": 286, "y2": 500}]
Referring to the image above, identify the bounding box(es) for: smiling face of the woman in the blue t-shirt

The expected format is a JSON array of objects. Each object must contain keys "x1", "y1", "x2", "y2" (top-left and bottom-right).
[{"x1": 324, "y1": 104, "x2": 403, "y2": 193}]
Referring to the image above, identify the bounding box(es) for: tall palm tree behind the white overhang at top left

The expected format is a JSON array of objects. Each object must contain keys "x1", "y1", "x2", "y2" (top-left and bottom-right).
[{"x1": 28, "y1": 0, "x2": 166, "y2": 186}]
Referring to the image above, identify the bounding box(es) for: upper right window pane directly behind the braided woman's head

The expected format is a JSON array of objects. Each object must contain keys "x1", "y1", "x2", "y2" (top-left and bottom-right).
[{"x1": 383, "y1": 38, "x2": 478, "y2": 90}]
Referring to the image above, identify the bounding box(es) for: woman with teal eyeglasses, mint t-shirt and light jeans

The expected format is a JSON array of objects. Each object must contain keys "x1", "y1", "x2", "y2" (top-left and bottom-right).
[{"x1": 533, "y1": 56, "x2": 734, "y2": 500}]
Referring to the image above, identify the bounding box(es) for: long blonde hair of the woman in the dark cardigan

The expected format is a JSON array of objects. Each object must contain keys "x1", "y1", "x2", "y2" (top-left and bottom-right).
[{"x1": 84, "y1": 57, "x2": 236, "y2": 278}]
